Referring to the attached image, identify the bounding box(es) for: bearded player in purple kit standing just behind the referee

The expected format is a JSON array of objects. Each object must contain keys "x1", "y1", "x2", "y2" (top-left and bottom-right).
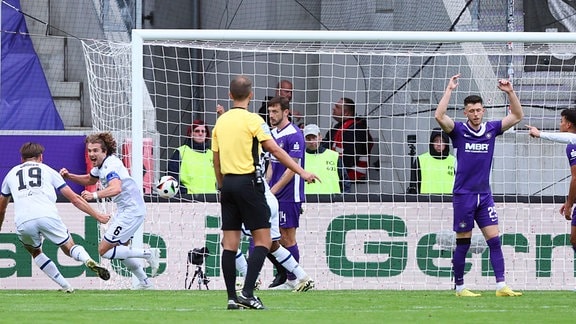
[{"x1": 268, "y1": 97, "x2": 306, "y2": 289}]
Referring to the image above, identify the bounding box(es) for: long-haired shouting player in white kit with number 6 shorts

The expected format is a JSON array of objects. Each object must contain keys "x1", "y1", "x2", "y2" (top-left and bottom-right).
[{"x1": 60, "y1": 132, "x2": 160, "y2": 289}]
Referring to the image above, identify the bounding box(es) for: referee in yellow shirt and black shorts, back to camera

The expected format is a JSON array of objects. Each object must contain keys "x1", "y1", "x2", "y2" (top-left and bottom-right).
[{"x1": 212, "y1": 76, "x2": 319, "y2": 309}]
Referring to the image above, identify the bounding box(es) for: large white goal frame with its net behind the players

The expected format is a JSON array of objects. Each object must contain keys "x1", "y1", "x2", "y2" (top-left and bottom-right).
[{"x1": 84, "y1": 30, "x2": 576, "y2": 289}]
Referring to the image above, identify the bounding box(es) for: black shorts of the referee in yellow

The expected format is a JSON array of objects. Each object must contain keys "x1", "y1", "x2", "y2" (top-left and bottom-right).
[{"x1": 220, "y1": 174, "x2": 270, "y2": 231}]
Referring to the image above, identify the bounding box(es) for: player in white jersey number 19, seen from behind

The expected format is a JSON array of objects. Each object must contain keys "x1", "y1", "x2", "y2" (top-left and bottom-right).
[{"x1": 0, "y1": 142, "x2": 110, "y2": 293}]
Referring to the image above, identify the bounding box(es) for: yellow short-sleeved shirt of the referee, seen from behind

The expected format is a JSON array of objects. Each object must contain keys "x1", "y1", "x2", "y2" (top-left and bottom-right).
[{"x1": 212, "y1": 108, "x2": 272, "y2": 174}]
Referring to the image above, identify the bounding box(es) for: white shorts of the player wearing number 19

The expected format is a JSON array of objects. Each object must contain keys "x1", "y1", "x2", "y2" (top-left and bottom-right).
[{"x1": 16, "y1": 217, "x2": 70, "y2": 248}]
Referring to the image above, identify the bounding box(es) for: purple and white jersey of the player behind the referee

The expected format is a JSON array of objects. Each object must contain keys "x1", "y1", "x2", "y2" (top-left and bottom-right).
[{"x1": 270, "y1": 123, "x2": 306, "y2": 202}]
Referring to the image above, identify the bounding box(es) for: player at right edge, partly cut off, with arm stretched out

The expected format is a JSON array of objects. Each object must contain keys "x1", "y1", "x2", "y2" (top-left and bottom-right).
[{"x1": 526, "y1": 109, "x2": 576, "y2": 270}]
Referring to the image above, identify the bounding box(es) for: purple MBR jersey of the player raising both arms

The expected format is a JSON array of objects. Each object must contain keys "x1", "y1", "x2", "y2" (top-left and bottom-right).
[{"x1": 448, "y1": 120, "x2": 502, "y2": 194}]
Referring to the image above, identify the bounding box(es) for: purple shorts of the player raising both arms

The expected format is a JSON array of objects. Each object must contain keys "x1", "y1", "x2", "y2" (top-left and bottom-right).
[{"x1": 452, "y1": 194, "x2": 498, "y2": 233}]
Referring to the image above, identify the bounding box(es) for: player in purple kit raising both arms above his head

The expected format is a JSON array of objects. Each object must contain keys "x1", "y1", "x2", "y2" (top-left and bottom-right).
[{"x1": 434, "y1": 74, "x2": 524, "y2": 297}]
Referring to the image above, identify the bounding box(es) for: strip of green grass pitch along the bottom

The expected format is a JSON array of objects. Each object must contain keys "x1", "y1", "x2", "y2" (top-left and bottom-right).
[{"x1": 0, "y1": 290, "x2": 576, "y2": 324}]
